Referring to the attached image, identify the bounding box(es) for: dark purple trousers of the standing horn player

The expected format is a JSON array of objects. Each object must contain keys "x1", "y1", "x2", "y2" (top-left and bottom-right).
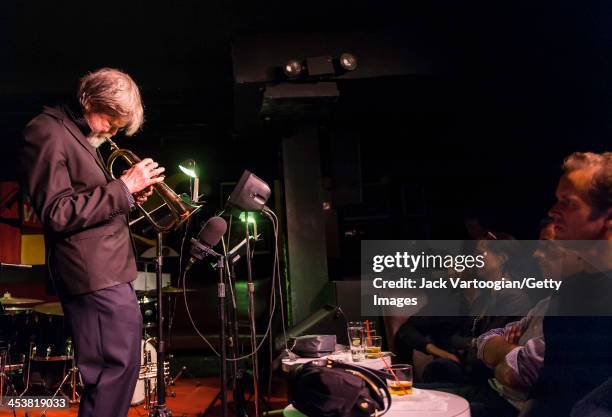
[{"x1": 61, "y1": 283, "x2": 142, "y2": 417}]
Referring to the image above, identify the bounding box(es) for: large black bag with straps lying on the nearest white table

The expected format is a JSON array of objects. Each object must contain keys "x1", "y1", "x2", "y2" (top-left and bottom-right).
[{"x1": 289, "y1": 360, "x2": 391, "y2": 417}]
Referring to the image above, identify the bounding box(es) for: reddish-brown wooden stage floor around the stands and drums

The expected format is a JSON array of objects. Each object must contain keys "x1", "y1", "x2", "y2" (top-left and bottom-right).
[{"x1": 0, "y1": 378, "x2": 287, "y2": 417}]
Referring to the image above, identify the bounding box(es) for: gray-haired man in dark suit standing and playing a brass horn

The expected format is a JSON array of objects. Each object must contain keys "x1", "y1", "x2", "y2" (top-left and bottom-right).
[{"x1": 22, "y1": 68, "x2": 164, "y2": 417}]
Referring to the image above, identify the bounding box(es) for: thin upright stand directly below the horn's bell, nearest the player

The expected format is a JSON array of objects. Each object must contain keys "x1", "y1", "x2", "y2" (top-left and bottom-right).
[{"x1": 149, "y1": 231, "x2": 172, "y2": 417}]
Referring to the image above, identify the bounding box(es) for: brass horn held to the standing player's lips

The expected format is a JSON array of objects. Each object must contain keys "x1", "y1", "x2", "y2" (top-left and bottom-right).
[{"x1": 106, "y1": 138, "x2": 202, "y2": 233}]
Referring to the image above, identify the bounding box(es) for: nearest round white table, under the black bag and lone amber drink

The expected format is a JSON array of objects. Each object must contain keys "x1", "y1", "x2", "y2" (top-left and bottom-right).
[{"x1": 283, "y1": 388, "x2": 470, "y2": 417}]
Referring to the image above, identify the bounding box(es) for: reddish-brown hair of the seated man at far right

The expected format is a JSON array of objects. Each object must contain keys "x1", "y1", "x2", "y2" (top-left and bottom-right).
[{"x1": 562, "y1": 152, "x2": 612, "y2": 213}]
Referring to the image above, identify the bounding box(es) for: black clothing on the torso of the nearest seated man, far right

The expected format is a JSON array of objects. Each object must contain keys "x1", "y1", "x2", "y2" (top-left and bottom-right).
[{"x1": 530, "y1": 271, "x2": 612, "y2": 417}]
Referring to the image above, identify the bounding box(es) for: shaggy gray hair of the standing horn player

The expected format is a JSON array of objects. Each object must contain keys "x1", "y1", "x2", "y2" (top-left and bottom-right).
[{"x1": 78, "y1": 68, "x2": 144, "y2": 136}]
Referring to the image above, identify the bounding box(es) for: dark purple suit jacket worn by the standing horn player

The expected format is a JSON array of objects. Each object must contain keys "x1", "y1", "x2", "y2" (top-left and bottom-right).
[{"x1": 22, "y1": 107, "x2": 136, "y2": 295}]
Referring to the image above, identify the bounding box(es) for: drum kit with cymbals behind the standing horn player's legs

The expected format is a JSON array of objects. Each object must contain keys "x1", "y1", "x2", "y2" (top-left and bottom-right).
[{"x1": 0, "y1": 286, "x2": 194, "y2": 409}]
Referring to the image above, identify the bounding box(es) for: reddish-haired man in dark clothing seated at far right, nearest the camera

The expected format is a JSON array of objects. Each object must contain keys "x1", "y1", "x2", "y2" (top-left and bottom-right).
[{"x1": 530, "y1": 152, "x2": 612, "y2": 417}]
